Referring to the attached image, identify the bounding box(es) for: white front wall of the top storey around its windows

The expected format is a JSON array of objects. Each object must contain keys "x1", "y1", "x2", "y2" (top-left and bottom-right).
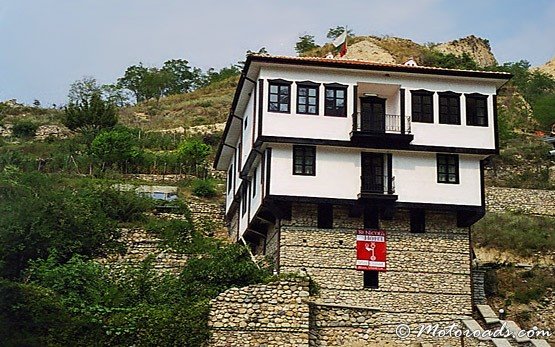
[{"x1": 259, "y1": 66, "x2": 496, "y2": 149}]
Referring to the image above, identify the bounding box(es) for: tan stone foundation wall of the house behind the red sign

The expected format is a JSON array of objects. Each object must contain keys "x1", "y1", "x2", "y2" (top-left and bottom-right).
[{"x1": 279, "y1": 204, "x2": 473, "y2": 346}]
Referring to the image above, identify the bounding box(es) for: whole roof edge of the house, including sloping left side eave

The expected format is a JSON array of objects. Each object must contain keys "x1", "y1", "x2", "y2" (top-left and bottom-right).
[{"x1": 214, "y1": 54, "x2": 513, "y2": 171}]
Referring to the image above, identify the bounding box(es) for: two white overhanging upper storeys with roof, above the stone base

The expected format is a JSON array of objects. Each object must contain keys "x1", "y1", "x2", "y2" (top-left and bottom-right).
[{"x1": 215, "y1": 55, "x2": 510, "y2": 243}]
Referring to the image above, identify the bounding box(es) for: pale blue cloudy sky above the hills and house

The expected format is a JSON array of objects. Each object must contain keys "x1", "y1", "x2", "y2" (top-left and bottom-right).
[{"x1": 0, "y1": 0, "x2": 555, "y2": 106}]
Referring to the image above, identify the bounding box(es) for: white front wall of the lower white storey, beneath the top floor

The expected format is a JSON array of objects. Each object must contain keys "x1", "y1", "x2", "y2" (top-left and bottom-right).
[{"x1": 270, "y1": 145, "x2": 481, "y2": 206}]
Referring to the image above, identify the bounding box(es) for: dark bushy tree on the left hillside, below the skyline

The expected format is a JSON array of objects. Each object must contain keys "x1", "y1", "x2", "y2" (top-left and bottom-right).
[{"x1": 64, "y1": 91, "x2": 118, "y2": 132}]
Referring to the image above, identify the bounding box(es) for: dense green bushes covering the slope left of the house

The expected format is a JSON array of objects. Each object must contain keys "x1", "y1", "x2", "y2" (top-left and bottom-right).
[{"x1": 0, "y1": 168, "x2": 269, "y2": 346}]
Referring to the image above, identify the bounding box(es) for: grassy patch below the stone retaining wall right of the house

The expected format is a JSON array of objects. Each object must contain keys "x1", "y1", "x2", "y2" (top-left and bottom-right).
[{"x1": 472, "y1": 213, "x2": 555, "y2": 256}]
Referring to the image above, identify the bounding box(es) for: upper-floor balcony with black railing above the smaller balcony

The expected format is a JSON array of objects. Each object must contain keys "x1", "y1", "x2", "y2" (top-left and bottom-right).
[{"x1": 350, "y1": 112, "x2": 414, "y2": 147}]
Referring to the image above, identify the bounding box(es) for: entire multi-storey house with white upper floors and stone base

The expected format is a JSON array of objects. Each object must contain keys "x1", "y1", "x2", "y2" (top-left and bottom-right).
[{"x1": 214, "y1": 55, "x2": 511, "y2": 346}]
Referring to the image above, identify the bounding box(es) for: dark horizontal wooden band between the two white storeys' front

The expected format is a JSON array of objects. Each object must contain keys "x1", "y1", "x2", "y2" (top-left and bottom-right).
[{"x1": 257, "y1": 136, "x2": 495, "y2": 155}]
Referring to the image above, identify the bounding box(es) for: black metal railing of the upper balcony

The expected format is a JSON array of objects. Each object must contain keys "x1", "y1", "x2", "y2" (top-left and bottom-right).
[{"x1": 353, "y1": 112, "x2": 411, "y2": 135}]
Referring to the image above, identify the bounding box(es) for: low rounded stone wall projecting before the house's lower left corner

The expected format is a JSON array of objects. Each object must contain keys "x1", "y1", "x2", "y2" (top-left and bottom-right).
[{"x1": 208, "y1": 278, "x2": 309, "y2": 347}]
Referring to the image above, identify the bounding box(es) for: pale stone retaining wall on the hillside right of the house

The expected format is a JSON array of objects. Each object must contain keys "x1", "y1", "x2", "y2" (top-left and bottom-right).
[{"x1": 486, "y1": 187, "x2": 555, "y2": 216}]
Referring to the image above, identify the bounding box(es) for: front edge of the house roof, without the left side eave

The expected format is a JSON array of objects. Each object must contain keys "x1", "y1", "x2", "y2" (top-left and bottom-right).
[{"x1": 250, "y1": 54, "x2": 512, "y2": 80}]
